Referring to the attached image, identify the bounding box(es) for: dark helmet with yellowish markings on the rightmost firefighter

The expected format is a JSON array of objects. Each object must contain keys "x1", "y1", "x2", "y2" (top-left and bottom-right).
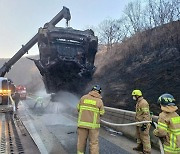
[{"x1": 158, "y1": 93, "x2": 176, "y2": 106}]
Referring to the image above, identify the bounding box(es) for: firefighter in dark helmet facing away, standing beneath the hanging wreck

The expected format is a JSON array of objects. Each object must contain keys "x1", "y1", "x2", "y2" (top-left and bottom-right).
[{"x1": 77, "y1": 85, "x2": 105, "y2": 154}]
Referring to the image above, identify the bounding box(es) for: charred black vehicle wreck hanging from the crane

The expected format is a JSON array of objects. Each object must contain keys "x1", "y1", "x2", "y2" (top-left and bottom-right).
[{"x1": 35, "y1": 24, "x2": 98, "y2": 93}]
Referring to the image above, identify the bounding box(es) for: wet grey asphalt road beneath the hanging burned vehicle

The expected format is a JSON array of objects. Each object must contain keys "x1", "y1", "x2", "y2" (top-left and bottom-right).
[{"x1": 18, "y1": 99, "x2": 159, "y2": 154}]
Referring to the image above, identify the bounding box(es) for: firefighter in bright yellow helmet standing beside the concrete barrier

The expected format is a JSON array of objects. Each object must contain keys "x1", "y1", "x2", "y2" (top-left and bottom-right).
[{"x1": 132, "y1": 90, "x2": 151, "y2": 154}]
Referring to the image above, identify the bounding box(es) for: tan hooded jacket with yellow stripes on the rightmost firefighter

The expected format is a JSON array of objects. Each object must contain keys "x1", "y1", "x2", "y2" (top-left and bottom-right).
[{"x1": 154, "y1": 106, "x2": 180, "y2": 154}]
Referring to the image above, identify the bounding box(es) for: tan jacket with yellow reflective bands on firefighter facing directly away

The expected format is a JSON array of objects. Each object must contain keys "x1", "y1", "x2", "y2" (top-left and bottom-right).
[{"x1": 77, "y1": 91, "x2": 105, "y2": 129}]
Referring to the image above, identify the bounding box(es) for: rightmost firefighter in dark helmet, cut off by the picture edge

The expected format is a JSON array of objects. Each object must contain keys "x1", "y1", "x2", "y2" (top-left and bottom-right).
[{"x1": 153, "y1": 94, "x2": 180, "y2": 154}]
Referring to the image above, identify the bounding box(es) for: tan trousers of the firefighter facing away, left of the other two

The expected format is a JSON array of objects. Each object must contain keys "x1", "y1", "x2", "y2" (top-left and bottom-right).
[{"x1": 77, "y1": 128, "x2": 99, "y2": 154}]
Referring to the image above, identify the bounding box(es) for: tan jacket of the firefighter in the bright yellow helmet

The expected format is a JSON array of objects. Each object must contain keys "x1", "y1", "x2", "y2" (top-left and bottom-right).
[{"x1": 135, "y1": 97, "x2": 151, "y2": 121}]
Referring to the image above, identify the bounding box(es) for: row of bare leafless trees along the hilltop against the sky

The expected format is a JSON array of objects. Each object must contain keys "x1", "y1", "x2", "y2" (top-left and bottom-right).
[{"x1": 92, "y1": 0, "x2": 180, "y2": 51}]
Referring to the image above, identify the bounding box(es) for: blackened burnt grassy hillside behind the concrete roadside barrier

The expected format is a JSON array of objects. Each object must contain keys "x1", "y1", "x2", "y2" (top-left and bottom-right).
[{"x1": 89, "y1": 21, "x2": 180, "y2": 114}]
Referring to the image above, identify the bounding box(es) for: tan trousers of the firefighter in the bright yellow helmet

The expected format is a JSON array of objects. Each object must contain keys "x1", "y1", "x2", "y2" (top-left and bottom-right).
[{"x1": 136, "y1": 124, "x2": 151, "y2": 153}]
